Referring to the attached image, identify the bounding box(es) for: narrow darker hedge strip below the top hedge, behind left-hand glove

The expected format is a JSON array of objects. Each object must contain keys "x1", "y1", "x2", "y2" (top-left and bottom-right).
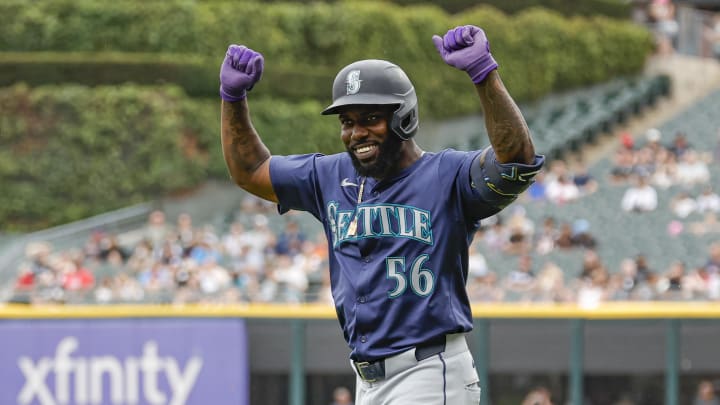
[{"x1": 0, "y1": 52, "x2": 335, "y2": 101}]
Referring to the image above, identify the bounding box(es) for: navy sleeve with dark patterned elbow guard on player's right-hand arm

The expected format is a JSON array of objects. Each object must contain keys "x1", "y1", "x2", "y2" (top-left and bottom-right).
[{"x1": 456, "y1": 147, "x2": 545, "y2": 219}]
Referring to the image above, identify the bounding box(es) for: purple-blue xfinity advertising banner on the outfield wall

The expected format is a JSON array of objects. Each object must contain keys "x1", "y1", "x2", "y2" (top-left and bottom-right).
[{"x1": 0, "y1": 318, "x2": 249, "y2": 405}]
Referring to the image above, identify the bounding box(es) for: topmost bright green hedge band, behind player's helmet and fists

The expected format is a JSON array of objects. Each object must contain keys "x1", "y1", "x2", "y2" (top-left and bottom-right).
[{"x1": 0, "y1": 0, "x2": 652, "y2": 110}]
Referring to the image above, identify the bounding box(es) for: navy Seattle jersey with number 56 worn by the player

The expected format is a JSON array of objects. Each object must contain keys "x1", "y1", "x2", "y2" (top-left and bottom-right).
[{"x1": 270, "y1": 149, "x2": 543, "y2": 361}]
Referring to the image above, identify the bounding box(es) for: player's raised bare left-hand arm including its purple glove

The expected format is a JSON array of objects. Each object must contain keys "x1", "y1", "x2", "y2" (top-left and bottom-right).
[{"x1": 220, "y1": 45, "x2": 277, "y2": 202}]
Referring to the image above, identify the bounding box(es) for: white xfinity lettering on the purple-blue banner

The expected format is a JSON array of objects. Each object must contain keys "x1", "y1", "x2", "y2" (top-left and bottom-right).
[{"x1": 17, "y1": 336, "x2": 203, "y2": 405}]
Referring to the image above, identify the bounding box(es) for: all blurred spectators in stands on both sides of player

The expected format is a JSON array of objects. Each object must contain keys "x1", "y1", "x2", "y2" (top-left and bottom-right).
[{"x1": 7, "y1": 123, "x2": 720, "y2": 305}]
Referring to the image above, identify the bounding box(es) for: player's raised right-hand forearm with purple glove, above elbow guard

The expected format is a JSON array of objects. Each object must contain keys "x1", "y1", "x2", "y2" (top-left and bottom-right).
[{"x1": 433, "y1": 25, "x2": 535, "y2": 164}]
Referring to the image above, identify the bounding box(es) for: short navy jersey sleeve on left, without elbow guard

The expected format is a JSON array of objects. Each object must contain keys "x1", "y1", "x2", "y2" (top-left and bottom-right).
[{"x1": 270, "y1": 154, "x2": 323, "y2": 218}]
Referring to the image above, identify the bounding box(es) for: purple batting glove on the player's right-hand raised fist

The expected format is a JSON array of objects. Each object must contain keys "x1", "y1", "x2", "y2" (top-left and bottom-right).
[{"x1": 433, "y1": 25, "x2": 498, "y2": 84}]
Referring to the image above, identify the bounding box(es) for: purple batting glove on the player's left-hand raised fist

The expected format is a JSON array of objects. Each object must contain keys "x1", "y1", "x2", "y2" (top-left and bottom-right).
[{"x1": 220, "y1": 45, "x2": 264, "y2": 102}]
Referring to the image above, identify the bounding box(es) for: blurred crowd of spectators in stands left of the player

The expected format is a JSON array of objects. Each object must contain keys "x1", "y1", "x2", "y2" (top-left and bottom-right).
[{"x1": 15, "y1": 200, "x2": 329, "y2": 304}]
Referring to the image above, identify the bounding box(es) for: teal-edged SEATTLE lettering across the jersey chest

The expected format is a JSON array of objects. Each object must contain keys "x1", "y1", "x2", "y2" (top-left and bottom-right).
[{"x1": 327, "y1": 201, "x2": 433, "y2": 246}]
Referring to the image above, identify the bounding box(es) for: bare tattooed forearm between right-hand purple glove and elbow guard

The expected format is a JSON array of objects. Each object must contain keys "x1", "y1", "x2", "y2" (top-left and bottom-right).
[{"x1": 476, "y1": 71, "x2": 535, "y2": 164}]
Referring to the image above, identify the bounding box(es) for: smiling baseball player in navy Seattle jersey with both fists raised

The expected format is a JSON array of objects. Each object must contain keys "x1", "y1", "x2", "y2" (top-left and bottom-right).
[{"x1": 220, "y1": 25, "x2": 544, "y2": 405}]
